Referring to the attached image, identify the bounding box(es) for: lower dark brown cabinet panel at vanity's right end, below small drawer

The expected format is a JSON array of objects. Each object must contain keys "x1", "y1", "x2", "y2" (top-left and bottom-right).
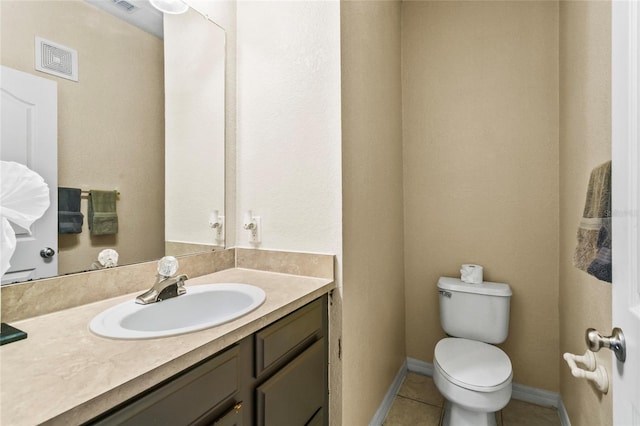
[{"x1": 256, "y1": 338, "x2": 326, "y2": 426}]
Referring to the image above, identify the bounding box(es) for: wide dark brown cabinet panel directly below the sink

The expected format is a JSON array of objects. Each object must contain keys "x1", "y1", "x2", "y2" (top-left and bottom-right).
[{"x1": 94, "y1": 346, "x2": 240, "y2": 426}]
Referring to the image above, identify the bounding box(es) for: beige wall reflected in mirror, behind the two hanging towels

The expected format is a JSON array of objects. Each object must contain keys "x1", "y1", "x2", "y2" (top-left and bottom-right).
[{"x1": 1, "y1": 1, "x2": 164, "y2": 273}]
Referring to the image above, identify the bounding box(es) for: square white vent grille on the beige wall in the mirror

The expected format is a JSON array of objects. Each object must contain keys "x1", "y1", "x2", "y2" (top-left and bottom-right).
[{"x1": 35, "y1": 37, "x2": 78, "y2": 81}]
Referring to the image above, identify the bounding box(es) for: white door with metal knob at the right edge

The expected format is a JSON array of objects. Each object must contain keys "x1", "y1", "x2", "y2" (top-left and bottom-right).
[{"x1": 611, "y1": 0, "x2": 640, "y2": 426}]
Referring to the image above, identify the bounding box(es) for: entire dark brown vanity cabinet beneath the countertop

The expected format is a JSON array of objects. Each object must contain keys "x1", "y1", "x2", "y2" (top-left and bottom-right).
[{"x1": 88, "y1": 296, "x2": 328, "y2": 426}]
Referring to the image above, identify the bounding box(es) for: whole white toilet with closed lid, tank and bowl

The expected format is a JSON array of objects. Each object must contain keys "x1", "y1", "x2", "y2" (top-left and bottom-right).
[{"x1": 433, "y1": 277, "x2": 513, "y2": 426}]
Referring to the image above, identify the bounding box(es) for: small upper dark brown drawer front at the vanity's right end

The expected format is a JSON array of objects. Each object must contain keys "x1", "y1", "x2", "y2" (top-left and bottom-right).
[{"x1": 255, "y1": 299, "x2": 323, "y2": 377}]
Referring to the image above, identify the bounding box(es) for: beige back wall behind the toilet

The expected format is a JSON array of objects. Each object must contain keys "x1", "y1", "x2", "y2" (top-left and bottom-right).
[{"x1": 402, "y1": 1, "x2": 559, "y2": 392}]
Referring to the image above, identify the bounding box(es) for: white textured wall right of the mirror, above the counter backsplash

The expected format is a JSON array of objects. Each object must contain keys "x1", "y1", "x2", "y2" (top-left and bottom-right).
[{"x1": 236, "y1": 1, "x2": 342, "y2": 254}]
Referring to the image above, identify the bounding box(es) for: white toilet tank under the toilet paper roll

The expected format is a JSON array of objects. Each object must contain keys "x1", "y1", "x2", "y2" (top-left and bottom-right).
[{"x1": 438, "y1": 277, "x2": 511, "y2": 343}]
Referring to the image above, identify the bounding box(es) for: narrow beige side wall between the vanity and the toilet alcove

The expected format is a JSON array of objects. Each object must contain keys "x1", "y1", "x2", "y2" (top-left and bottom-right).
[{"x1": 340, "y1": 1, "x2": 406, "y2": 425}]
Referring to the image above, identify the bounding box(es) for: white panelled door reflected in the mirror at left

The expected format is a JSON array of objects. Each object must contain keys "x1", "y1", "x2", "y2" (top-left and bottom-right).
[{"x1": 0, "y1": 66, "x2": 58, "y2": 284}]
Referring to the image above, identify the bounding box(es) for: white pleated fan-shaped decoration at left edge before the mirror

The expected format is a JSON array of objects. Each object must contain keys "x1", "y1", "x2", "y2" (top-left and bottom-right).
[{"x1": 0, "y1": 161, "x2": 50, "y2": 275}]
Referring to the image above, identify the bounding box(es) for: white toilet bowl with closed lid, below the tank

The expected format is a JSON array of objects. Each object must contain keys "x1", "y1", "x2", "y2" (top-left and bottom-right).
[{"x1": 433, "y1": 337, "x2": 513, "y2": 426}]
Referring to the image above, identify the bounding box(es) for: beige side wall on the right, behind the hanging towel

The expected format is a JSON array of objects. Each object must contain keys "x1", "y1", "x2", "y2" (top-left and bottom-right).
[{"x1": 560, "y1": 1, "x2": 615, "y2": 425}]
